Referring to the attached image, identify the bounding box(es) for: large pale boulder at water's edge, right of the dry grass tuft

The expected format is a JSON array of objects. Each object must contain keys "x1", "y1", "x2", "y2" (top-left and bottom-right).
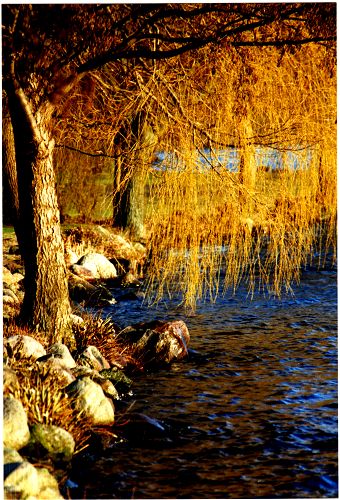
[{"x1": 67, "y1": 377, "x2": 115, "y2": 425}]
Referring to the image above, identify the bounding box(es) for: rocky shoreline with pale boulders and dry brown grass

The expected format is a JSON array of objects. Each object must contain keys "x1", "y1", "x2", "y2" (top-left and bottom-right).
[{"x1": 3, "y1": 226, "x2": 190, "y2": 500}]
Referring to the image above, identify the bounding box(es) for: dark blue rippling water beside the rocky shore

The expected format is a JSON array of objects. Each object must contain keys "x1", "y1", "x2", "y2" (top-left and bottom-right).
[{"x1": 77, "y1": 268, "x2": 338, "y2": 498}]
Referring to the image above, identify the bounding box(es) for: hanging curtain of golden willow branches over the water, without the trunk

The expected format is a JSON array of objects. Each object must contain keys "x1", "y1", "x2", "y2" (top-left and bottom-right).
[{"x1": 145, "y1": 44, "x2": 336, "y2": 307}]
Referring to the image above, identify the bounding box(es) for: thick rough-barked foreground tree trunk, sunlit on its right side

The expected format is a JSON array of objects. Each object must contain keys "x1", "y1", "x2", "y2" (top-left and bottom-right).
[{"x1": 8, "y1": 85, "x2": 73, "y2": 345}]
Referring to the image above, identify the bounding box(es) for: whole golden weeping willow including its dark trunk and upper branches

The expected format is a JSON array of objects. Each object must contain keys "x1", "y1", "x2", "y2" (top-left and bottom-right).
[{"x1": 49, "y1": 4, "x2": 336, "y2": 307}]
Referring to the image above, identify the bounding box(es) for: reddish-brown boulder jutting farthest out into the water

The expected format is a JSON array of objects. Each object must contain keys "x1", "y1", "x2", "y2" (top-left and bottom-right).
[{"x1": 119, "y1": 320, "x2": 190, "y2": 366}]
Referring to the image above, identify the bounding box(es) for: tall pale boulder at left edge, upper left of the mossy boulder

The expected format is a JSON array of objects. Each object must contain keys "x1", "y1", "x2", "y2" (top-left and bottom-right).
[{"x1": 3, "y1": 398, "x2": 30, "y2": 450}]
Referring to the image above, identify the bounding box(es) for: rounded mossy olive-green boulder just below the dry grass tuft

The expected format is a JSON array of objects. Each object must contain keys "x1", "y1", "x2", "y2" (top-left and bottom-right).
[{"x1": 31, "y1": 424, "x2": 75, "y2": 461}]
